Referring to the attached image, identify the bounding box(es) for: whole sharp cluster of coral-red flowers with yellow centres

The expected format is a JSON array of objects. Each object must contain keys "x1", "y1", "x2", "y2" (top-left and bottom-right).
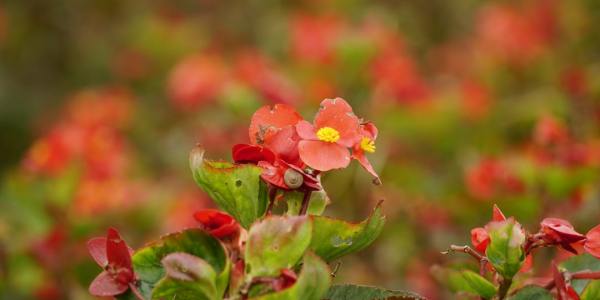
[{"x1": 232, "y1": 98, "x2": 379, "y2": 190}]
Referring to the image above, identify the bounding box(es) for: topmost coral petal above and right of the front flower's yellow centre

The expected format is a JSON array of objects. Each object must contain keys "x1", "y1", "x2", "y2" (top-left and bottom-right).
[{"x1": 315, "y1": 98, "x2": 361, "y2": 147}]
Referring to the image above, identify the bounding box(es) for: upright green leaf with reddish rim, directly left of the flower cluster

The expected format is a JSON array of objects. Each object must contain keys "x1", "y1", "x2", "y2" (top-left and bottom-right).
[{"x1": 190, "y1": 148, "x2": 268, "y2": 229}]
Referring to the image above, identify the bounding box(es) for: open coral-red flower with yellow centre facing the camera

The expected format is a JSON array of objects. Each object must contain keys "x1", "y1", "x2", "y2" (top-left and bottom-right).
[{"x1": 296, "y1": 98, "x2": 361, "y2": 171}]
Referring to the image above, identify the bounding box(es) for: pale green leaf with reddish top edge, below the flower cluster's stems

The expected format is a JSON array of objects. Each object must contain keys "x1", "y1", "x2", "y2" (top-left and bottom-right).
[{"x1": 245, "y1": 216, "x2": 312, "y2": 276}]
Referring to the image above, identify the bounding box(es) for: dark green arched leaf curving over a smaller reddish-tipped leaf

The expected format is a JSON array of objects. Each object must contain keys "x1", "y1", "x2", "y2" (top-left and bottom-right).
[{"x1": 122, "y1": 229, "x2": 230, "y2": 299}]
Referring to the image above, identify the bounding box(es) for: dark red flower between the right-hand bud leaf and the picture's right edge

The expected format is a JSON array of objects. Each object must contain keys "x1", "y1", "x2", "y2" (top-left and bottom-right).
[{"x1": 540, "y1": 218, "x2": 585, "y2": 254}]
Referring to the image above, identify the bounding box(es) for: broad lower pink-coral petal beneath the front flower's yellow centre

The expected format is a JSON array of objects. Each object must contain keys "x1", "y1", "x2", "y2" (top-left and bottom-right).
[{"x1": 298, "y1": 141, "x2": 350, "y2": 171}]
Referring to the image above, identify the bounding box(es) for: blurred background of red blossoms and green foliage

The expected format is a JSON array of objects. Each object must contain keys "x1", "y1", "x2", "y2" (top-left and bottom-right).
[{"x1": 0, "y1": 0, "x2": 600, "y2": 299}]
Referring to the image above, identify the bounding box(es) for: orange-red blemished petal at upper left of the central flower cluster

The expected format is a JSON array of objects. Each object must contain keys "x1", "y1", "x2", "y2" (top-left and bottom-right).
[{"x1": 248, "y1": 104, "x2": 302, "y2": 144}]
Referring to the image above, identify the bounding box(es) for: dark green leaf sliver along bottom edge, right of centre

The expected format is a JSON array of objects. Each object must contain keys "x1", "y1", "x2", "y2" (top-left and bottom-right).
[{"x1": 324, "y1": 284, "x2": 425, "y2": 300}]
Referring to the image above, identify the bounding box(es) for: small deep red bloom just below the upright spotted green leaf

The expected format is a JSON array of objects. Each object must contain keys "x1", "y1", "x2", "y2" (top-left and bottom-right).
[{"x1": 194, "y1": 209, "x2": 240, "y2": 240}]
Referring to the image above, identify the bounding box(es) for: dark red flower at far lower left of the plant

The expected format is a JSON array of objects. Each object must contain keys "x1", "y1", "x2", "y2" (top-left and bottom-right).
[{"x1": 87, "y1": 228, "x2": 135, "y2": 297}]
